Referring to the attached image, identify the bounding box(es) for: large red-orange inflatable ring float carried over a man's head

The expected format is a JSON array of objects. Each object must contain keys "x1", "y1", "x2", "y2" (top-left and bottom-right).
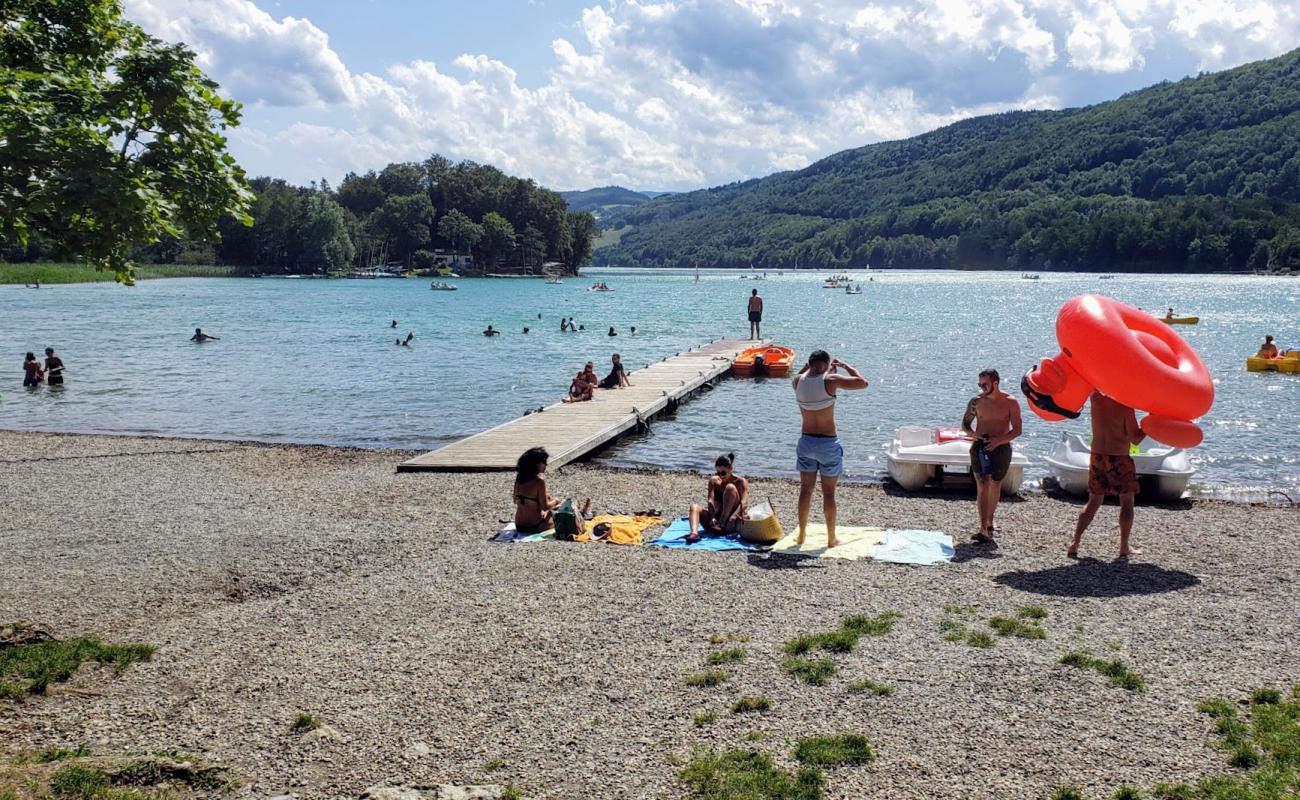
[{"x1": 1021, "y1": 294, "x2": 1214, "y2": 447}]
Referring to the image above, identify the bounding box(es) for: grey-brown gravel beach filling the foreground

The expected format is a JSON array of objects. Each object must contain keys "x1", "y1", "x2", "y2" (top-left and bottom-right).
[{"x1": 0, "y1": 432, "x2": 1300, "y2": 799}]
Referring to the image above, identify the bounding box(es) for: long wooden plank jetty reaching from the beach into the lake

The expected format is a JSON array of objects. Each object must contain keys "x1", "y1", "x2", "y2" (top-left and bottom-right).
[{"x1": 398, "y1": 340, "x2": 767, "y2": 472}]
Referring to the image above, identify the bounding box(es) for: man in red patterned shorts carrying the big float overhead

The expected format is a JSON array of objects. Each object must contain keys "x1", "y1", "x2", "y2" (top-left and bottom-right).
[{"x1": 1066, "y1": 392, "x2": 1147, "y2": 558}]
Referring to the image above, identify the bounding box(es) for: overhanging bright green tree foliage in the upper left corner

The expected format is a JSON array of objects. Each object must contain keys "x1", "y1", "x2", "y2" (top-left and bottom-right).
[{"x1": 0, "y1": 0, "x2": 250, "y2": 282}]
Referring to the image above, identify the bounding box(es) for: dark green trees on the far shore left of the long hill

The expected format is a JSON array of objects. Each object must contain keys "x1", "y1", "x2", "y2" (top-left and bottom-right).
[{"x1": 0, "y1": 155, "x2": 598, "y2": 273}]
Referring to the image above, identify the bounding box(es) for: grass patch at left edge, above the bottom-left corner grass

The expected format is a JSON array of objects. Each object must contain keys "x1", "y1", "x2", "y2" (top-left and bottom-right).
[{"x1": 0, "y1": 636, "x2": 155, "y2": 697}]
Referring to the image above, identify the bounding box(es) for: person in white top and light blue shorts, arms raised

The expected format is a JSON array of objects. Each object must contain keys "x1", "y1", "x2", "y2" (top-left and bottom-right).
[{"x1": 793, "y1": 350, "x2": 867, "y2": 548}]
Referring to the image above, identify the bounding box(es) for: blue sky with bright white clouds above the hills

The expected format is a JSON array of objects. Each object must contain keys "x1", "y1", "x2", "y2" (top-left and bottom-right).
[{"x1": 125, "y1": 0, "x2": 1300, "y2": 191}]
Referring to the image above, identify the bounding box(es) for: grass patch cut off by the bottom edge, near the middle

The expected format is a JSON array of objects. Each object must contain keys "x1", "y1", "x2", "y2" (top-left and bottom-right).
[{"x1": 677, "y1": 749, "x2": 826, "y2": 800}]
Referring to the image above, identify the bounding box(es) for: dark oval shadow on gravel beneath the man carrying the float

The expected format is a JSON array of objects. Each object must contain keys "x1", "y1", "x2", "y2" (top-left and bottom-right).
[{"x1": 993, "y1": 558, "x2": 1201, "y2": 597}]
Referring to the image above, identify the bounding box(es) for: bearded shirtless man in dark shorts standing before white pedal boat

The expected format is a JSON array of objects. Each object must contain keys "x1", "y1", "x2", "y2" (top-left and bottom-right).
[{"x1": 962, "y1": 369, "x2": 1021, "y2": 542}]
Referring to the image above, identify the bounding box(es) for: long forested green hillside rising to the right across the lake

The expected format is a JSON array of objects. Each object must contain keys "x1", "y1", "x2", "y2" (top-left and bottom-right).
[{"x1": 595, "y1": 49, "x2": 1300, "y2": 271}]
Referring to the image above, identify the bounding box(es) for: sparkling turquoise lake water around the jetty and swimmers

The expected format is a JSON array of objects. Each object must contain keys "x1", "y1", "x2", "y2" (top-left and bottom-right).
[{"x1": 0, "y1": 271, "x2": 1300, "y2": 497}]
